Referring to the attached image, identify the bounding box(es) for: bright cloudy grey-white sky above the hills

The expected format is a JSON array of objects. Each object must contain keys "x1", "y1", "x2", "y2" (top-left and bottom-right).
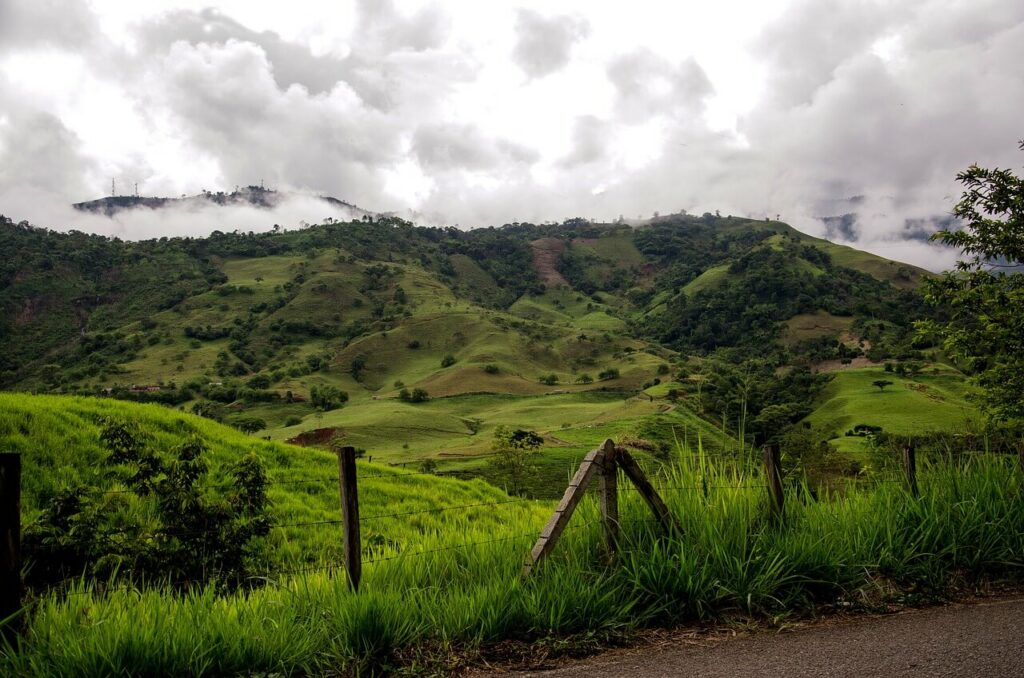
[{"x1": 0, "y1": 0, "x2": 1024, "y2": 269}]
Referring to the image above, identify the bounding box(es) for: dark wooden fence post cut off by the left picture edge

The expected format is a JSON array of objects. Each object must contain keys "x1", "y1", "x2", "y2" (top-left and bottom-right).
[{"x1": 0, "y1": 452, "x2": 22, "y2": 638}]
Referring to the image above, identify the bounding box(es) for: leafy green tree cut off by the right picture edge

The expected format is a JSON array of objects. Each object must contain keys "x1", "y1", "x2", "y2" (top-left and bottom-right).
[{"x1": 919, "y1": 141, "x2": 1024, "y2": 428}]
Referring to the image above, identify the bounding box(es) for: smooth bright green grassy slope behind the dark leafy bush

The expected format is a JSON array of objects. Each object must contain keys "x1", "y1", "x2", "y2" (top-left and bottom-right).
[{"x1": 0, "y1": 393, "x2": 550, "y2": 567}]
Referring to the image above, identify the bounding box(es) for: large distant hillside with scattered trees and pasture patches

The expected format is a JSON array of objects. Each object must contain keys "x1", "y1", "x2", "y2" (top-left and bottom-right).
[{"x1": 0, "y1": 214, "x2": 950, "y2": 483}]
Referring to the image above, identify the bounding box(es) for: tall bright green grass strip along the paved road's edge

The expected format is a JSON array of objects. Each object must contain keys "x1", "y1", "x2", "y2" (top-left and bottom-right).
[{"x1": 0, "y1": 440, "x2": 1024, "y2": 676}]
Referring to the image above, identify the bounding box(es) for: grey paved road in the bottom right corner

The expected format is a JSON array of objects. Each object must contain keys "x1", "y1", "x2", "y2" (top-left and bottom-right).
[{"x1": 491, "y1": 598, "x2": 1024, "y2": 678}]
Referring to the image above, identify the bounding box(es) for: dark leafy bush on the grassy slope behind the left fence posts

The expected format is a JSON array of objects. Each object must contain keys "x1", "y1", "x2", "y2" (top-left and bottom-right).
[{"x1": 25, "y1": 420, "x2": 269, "y2": 586}]
